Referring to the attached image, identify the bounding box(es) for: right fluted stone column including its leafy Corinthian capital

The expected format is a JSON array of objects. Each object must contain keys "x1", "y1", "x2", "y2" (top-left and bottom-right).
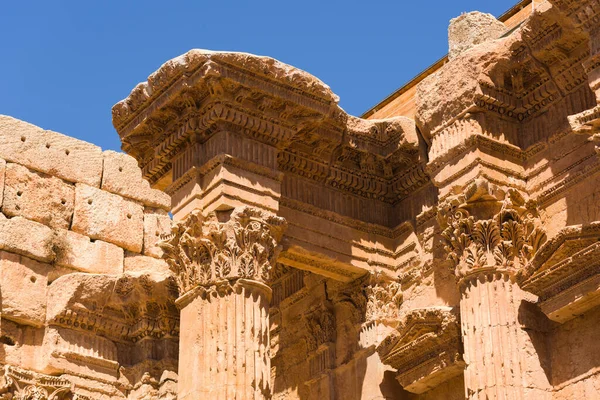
[{"x1": 438, "y1": 181, "x2": 550, "y2": 400}]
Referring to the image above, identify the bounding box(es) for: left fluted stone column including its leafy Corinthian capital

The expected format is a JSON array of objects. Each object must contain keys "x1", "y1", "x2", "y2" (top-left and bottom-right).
[{"x1": 161, "y1": 207, "x2": 285, "y2": 400}]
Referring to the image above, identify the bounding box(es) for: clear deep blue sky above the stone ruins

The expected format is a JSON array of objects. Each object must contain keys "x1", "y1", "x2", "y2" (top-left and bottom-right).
[{"x1": 0, "y1": 0, "x2": 517, "y2": 150}]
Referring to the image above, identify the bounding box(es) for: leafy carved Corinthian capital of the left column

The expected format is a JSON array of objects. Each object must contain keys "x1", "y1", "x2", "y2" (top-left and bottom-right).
[{"x1": 159, "y1": 207, "x2": 286, "y2": 294}]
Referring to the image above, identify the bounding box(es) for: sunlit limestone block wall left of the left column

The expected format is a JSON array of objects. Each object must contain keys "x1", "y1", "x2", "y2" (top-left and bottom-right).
[{"x1": 0, "y1": 116, "x2": 178, "y2": 399}]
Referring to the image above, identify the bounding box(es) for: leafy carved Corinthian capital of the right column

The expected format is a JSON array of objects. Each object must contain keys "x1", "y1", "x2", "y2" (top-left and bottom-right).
[{"x1": 438, "y1": 182, "x2": 547, "y2": 278}]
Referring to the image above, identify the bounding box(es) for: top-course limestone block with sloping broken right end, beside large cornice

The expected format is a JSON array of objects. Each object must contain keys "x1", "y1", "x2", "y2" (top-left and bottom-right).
[{"x1": 102, "y1": 150, "x2": 171, "y2": 211}]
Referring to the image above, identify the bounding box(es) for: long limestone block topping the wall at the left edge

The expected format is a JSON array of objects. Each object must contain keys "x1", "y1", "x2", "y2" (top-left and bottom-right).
[{"x1": 0, "y1": 115, "x2": 102, "y2": 187}]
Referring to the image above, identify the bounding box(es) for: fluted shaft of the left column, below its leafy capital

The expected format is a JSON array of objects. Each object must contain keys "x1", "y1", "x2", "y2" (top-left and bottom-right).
[{"x1": 179, "y1": 279, "x2": 271, "y2": 400}]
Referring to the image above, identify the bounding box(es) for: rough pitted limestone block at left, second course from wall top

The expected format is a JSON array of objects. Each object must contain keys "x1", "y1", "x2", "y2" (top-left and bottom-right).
[{"x1": 2, "y1": 163, "x2": 75, "y2": 229}]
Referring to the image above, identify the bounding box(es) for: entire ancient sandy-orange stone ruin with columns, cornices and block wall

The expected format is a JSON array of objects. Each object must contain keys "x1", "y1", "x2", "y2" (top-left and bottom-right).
[{"x1": 0, "y1": 0, "x2": 600, "y2": 400}]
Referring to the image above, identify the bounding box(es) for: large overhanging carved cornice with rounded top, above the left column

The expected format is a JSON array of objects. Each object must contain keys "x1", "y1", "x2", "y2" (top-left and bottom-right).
[{"x1": 113, "y1": 50, "x2": 428, "y2": 211}]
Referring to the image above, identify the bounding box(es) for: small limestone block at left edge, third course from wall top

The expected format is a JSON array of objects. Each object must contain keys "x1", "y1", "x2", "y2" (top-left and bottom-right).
[{"x1": 0, "y1": 217, "x2": 54, "y2": 262}]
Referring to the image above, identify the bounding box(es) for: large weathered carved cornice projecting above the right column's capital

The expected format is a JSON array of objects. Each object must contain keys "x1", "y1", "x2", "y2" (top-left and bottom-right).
[{"x1": 416, "y1": 5, "x2": 592, "y2": 162}]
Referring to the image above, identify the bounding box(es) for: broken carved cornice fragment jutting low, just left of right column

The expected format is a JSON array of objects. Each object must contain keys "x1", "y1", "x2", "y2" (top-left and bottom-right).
[{"x1": 377, "y1": 307, "x2": 464, "y2": 393}]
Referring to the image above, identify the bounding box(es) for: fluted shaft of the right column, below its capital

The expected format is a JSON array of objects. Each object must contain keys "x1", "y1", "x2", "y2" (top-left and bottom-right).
[{"x1": 460, "y1": 267, "x2": 528, "y2": 400}]
